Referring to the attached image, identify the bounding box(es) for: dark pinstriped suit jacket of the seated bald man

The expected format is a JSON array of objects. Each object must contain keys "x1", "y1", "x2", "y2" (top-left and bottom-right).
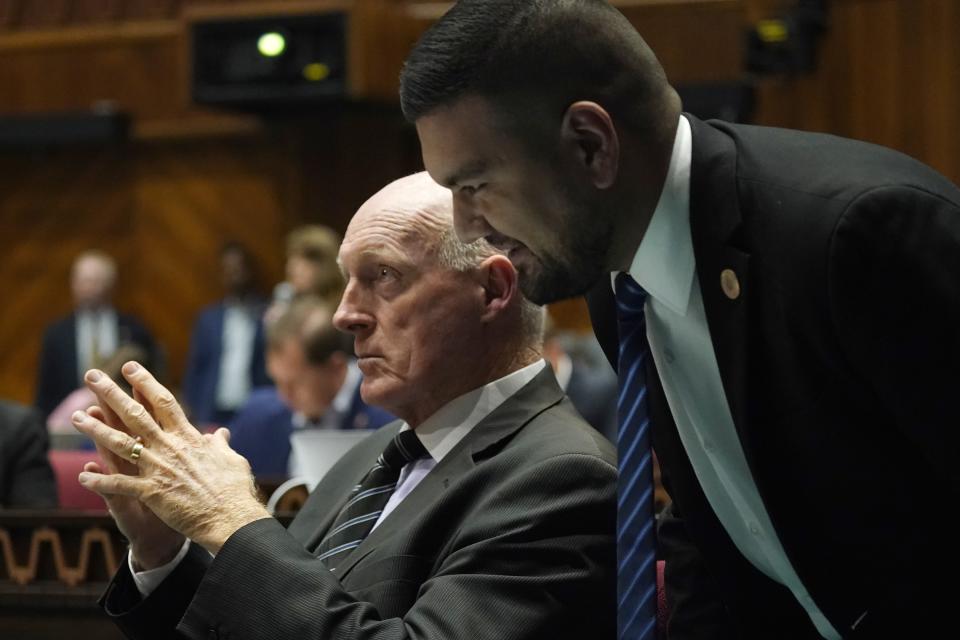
[{"x1": 105, "y1": 367, "x2": 616, "y2": 640}]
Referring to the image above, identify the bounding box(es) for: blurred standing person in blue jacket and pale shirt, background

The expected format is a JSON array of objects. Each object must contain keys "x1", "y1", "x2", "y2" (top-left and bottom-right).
[{"x1": 183, "y1": 242, "x2": 270, "y2": 425}]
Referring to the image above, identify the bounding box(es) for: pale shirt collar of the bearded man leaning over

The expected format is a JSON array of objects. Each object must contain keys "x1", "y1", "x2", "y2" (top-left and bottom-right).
[{"x1": 629, "y1": 116, "x2": 696, "y2": 315}]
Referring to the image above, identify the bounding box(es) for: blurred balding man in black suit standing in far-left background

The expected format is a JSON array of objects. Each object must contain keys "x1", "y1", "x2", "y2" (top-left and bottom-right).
[{"x1": 35, "y1": 251, "x2": 156, "y2": 417}]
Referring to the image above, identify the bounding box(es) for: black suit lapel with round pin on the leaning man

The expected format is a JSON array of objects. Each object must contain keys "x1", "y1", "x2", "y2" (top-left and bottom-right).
[{"x1": 686, "y1": 115, "x2": 752, "y2": 466}]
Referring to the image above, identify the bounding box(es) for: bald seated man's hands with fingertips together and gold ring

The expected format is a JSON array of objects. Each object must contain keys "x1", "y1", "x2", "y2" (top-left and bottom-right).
[{"x1": 73, "y1": 362, "x2": 270, "y2": 569}]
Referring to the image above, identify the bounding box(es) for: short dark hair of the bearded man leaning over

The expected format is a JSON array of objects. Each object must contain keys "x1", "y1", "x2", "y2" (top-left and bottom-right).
[{"x1": 400, "y1": 0, "x2": 675, "y2": 136}]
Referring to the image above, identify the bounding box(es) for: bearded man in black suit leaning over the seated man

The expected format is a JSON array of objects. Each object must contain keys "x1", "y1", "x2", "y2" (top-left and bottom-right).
[{"x1": 401, "y1": 0, "x2": 960, "y2": 640}]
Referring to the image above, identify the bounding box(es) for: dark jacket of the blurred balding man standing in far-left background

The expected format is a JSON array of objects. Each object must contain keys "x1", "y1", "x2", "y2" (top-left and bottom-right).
[{"x1": 35, "y1": 311, "x2": 158, "y2": 416}]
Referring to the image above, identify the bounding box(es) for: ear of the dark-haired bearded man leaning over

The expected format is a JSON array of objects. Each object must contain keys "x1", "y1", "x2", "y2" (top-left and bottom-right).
[{"x1": 560, "y1": 100, "x2": 620, "y2": 189}]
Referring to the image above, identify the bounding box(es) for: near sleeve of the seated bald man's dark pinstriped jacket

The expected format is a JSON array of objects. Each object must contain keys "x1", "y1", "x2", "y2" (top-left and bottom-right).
[{"x1": 159, "y1": 454, "x2": 616, "y2": 640}]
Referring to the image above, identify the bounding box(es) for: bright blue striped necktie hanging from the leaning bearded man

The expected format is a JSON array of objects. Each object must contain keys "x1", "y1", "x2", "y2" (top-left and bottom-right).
[{"x1": 616, "y1": 273, "x2": 657, "y2": 640}]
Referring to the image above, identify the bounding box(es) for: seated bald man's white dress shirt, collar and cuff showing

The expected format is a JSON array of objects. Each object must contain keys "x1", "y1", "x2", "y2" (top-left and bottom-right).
[{"x1": 127, "y1": 360, "x2": 547, "y2": 597}]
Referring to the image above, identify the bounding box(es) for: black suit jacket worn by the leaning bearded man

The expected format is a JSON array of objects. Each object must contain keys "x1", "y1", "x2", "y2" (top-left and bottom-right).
[{"x1": 589, "y1": 118, "x2": 960, "y2": 639}]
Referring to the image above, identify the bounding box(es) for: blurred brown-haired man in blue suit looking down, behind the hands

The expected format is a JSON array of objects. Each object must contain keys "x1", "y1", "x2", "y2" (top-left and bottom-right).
[{"x1": 229, "y1": 295, "x2": 394, "y2": 478}]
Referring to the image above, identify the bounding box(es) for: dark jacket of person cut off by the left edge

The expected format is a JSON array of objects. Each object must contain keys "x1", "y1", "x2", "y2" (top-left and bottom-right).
[{"x1": 0, "y1": 400, "x2": 57, "y2": 509}]
